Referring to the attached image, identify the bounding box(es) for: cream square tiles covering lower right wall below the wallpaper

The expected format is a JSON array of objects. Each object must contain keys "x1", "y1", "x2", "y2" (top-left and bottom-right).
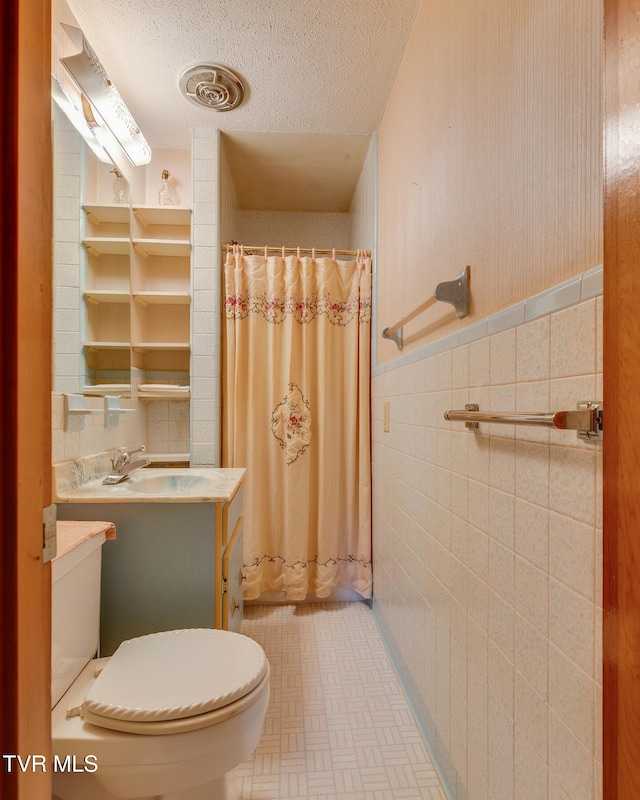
[{"x1": 373, "y1": 273, "x2": 602, "y2": 800}]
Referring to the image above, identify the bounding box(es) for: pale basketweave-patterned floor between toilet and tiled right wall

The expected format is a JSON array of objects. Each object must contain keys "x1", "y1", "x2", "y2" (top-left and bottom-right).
[{"x1": 234, "y1": 602, "x2": 445, "y2": 800}]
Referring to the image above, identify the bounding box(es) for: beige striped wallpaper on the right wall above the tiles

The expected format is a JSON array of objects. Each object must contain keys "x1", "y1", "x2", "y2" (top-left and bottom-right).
[{"x1": 376, "y1": 0, "x2": 602, "y2": 362}]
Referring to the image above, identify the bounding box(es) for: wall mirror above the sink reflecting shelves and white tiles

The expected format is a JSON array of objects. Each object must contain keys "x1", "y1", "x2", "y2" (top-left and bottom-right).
[{"x1": 52, "y1": 102, "x2": 131, "y2": 397}]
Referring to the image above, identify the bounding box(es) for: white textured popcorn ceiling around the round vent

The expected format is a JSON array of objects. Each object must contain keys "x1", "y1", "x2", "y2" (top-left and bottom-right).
[{"x1": 67, "y1": 0, "x2": 420, "y2": 148}]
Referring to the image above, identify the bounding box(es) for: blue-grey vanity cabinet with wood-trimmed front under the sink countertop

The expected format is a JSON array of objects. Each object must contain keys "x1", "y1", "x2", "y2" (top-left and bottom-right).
[{"x1": 57, "y1": 486, "x2": 243, "y2": 656}]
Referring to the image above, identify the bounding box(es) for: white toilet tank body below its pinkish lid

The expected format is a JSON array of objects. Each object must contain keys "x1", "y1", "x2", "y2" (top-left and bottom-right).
[{"x1": 51, "y1": 533, "x2": 106, "y2": 708}]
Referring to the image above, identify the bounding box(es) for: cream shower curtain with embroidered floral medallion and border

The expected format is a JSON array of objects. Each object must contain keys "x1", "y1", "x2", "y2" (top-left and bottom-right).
[{"x1": 222, "y1": 247, "x2": 372, "y2": 600}]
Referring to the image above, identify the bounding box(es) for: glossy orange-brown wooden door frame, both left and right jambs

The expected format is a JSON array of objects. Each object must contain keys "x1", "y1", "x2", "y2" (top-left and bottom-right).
[{"x1": 0, "y1": 0, "x2": 640, "y2": 800}]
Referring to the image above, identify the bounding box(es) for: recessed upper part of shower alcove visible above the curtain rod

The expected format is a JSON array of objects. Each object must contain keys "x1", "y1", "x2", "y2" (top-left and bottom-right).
[{"x1": 220, "y1": 132, "x2": 373, "y2": 258}]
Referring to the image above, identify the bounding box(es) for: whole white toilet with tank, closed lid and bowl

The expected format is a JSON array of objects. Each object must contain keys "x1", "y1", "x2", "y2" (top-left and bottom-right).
[{"x1": 51, "y1": 533, "x2": 269, "y2": 800}]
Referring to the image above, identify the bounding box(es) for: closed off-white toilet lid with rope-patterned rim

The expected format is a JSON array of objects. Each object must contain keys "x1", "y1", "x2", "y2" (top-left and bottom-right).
[{"x1": 82, "y1": 628, "x2": 269, "y2": 727}]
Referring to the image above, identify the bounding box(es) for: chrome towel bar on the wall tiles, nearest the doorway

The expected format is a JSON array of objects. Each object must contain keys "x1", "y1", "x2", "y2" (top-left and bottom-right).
[{"x1": 444, "y1": 400, "x2": 603, "y2": 440}]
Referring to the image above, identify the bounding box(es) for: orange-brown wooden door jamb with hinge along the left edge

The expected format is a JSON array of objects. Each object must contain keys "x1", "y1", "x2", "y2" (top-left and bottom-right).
[{"x1": 0, "y1": 0, "x2": 53, "y2": 800}]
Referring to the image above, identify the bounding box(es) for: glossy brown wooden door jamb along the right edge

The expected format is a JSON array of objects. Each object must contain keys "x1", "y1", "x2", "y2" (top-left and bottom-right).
[{"x1": 603, "y1": 0, "x2": 640, "y2": 800}]
